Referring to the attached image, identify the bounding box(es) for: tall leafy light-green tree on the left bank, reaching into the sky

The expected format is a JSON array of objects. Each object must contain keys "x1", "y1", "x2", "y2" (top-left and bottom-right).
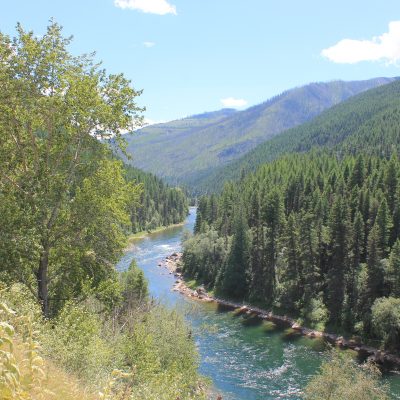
[{"x1": 0, "y1": 22, "x2": 142, "y2": 315}]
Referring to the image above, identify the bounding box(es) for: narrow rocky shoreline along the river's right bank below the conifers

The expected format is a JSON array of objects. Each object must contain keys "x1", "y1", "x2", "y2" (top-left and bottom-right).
[{"x1": 158, "y1": 252, "x2": 400, "y2": 370}]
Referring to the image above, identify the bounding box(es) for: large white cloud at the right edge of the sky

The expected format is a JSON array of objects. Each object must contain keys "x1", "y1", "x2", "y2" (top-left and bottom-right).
[{"x1": 321, "y1": 21, "x2": 400, "y2": 64}]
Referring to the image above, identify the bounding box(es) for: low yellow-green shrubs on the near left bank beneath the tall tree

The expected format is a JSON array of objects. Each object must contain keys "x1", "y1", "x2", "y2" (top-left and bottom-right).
[{"x1": 0, "y1": 282, "x2": 205, "y2": 400}]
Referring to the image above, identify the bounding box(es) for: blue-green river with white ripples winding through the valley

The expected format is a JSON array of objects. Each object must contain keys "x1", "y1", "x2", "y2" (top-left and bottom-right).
[{"x1": 117, "y1": 208, "x2": 400, "y2": 400}]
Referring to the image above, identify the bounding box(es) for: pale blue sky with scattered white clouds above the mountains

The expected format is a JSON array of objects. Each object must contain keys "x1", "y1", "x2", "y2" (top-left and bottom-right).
[{"x1": 0, "y1": 0, "x2": 400, "y2": 123}]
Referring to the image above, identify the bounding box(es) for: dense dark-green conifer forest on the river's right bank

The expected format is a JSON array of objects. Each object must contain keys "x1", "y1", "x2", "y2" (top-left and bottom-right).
[{"x1": 184, "y1": 152, "x2": 400, "y2": 351}]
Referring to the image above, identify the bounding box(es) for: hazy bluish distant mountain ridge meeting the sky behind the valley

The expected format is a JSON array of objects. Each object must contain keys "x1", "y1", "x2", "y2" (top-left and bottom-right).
[{"x1": 126, "y1": 78, "x2": 393, "y2": 186}]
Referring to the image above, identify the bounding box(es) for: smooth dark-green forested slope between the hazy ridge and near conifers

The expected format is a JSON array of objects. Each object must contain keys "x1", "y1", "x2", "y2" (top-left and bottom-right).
[{"x1": 196, "y1": 80, "x2": 400, "y2": 193}]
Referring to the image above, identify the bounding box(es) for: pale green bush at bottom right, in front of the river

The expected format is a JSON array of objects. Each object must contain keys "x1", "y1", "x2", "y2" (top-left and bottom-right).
[{"x1": 303, "y1": 352, "x2": 389, "y2": 400}]
